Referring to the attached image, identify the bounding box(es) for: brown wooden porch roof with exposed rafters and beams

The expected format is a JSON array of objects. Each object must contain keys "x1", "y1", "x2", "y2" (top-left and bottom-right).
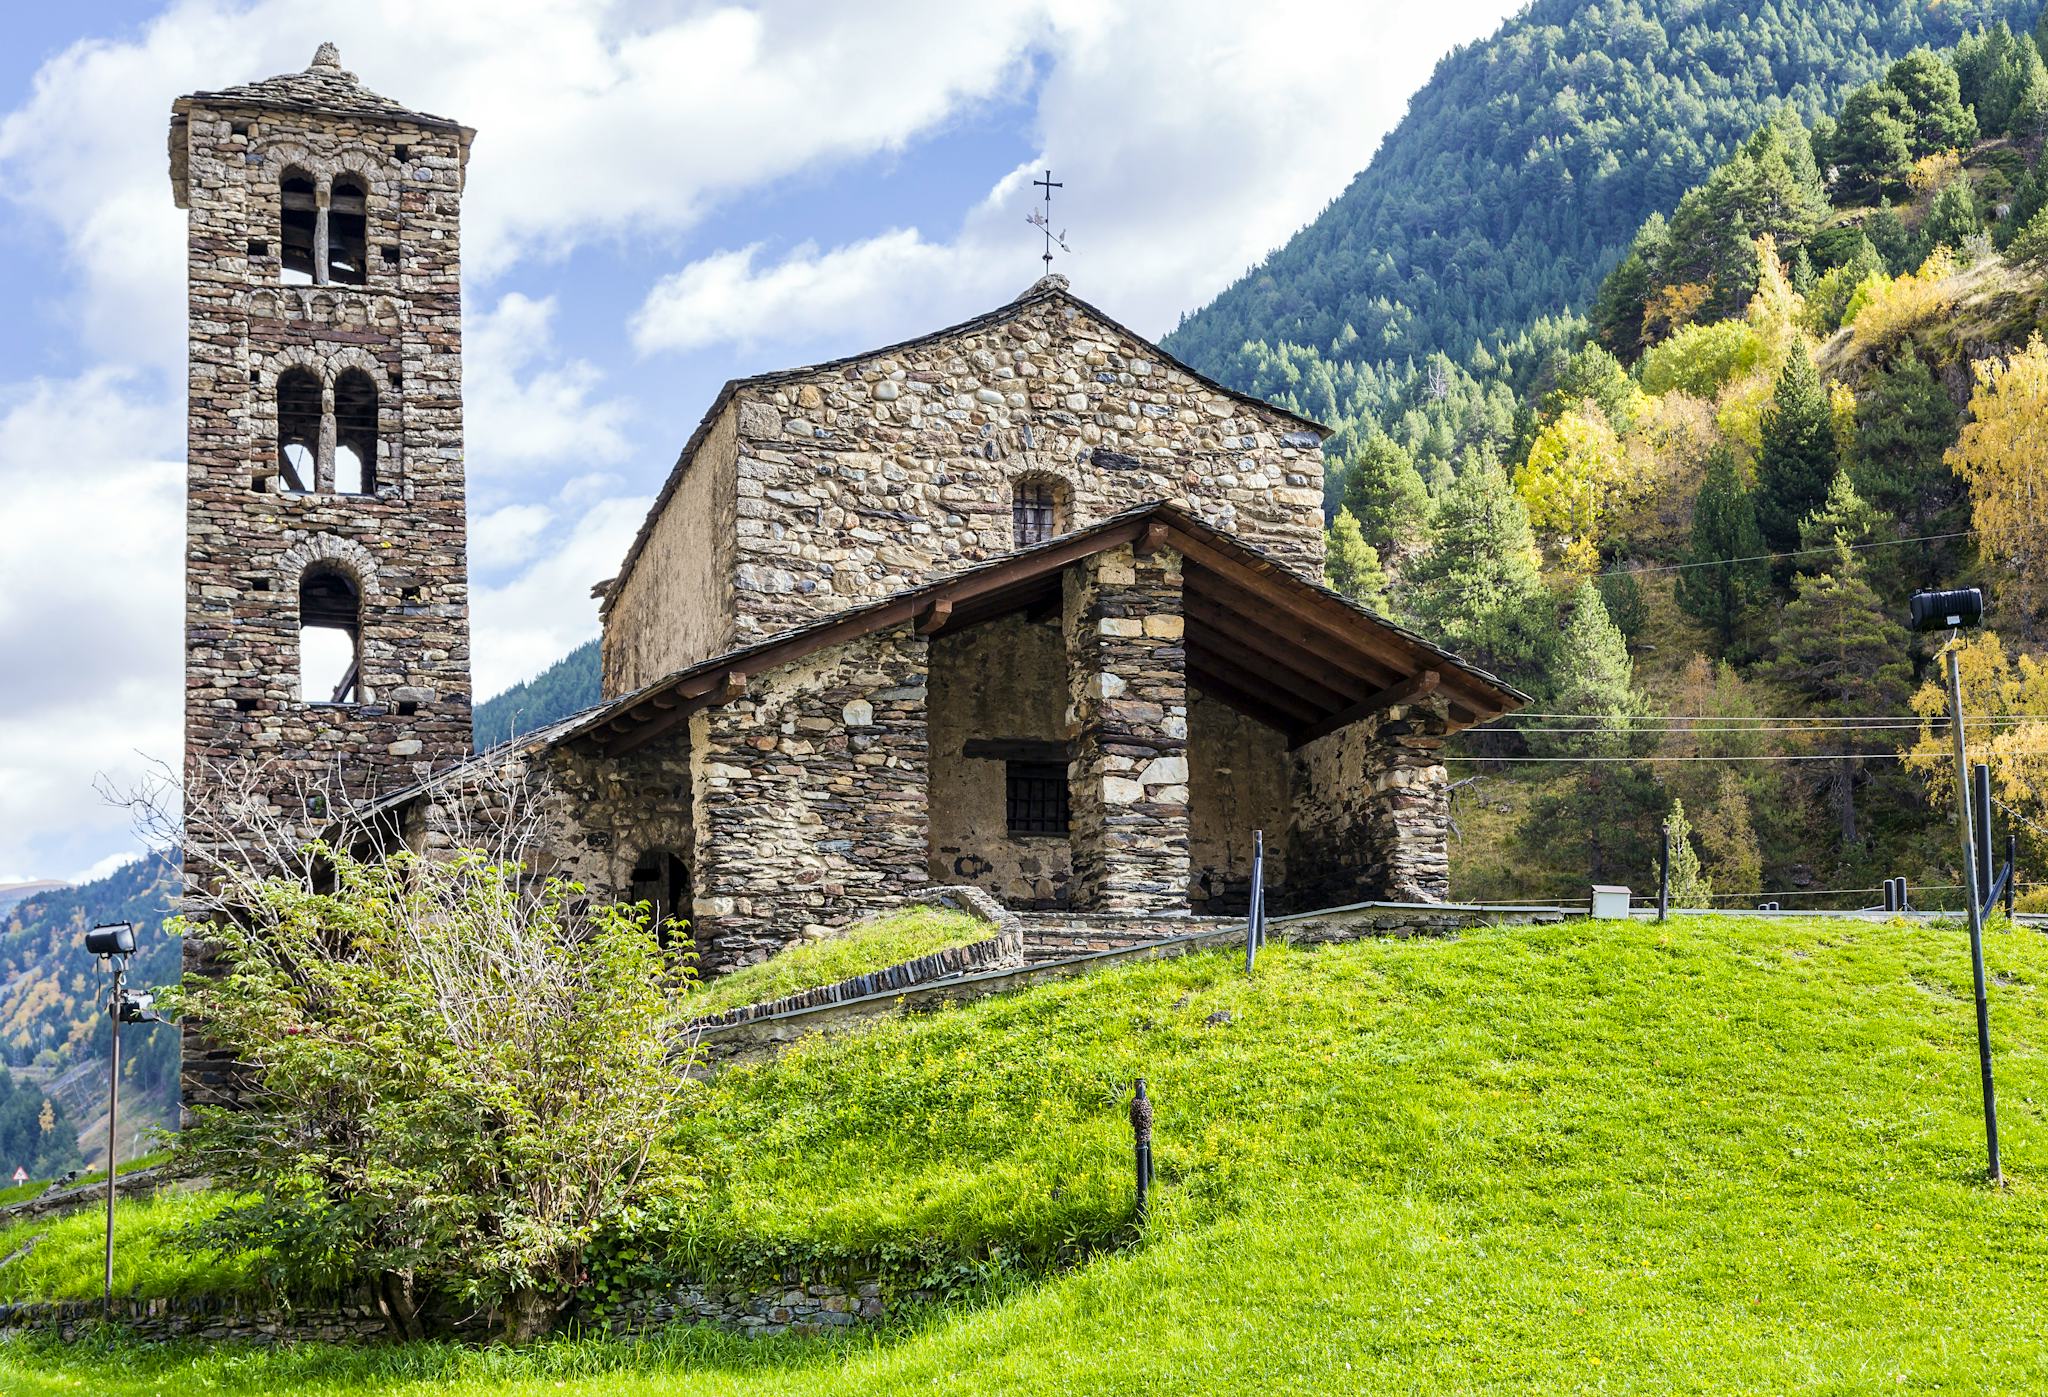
[{"x1": 551, "y1": 504, "x2": 1528, "y2": 756}]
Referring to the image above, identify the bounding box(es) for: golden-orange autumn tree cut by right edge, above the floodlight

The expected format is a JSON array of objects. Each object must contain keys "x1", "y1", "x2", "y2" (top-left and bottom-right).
[{"x1": 1948, "y1": 334, "x2": 2048, "y2": 615}]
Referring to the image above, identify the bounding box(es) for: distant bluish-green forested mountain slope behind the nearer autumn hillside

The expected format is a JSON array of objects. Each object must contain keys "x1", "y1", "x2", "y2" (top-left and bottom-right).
[{"x1": 1165, "y1": 0, "x2": 2040, "y2": 448}]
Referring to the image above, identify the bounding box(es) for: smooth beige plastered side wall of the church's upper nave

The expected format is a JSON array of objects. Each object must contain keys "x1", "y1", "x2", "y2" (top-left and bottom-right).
[{"x1": 602, "y1": 406, "x2": 737, "y2": 699}]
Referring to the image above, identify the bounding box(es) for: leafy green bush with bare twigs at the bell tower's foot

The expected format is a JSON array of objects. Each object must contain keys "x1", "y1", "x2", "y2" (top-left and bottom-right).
[{"x1": 176, "y1": 846, "x2": 688, "y2": 1340}]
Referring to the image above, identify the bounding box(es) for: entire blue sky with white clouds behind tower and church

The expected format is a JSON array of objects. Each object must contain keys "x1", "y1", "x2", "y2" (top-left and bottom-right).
[{"x1": 0, "y1": 0, "x2": 1511, "y2": 883}]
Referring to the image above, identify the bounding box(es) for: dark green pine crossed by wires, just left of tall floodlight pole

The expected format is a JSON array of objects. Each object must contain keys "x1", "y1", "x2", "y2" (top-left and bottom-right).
[{"x1": 1765, "y1": 547, "x2": 1913, "y2": 848}]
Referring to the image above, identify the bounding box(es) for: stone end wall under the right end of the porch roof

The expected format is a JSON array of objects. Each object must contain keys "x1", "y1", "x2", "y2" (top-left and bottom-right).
[{"x1": 1274, "y1": 696, "x2": 1450, "y2": 912}]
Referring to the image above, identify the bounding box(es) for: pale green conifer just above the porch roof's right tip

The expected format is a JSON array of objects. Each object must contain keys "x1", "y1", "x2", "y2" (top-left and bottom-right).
[{"x1": 1403, "y1": 457, "x2": 1542, "y2": 668}]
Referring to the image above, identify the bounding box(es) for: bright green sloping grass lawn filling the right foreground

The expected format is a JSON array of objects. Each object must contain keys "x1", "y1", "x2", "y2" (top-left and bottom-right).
[{"x1": 0, "y1": 918, "x2": 2048, "y2": 1397}]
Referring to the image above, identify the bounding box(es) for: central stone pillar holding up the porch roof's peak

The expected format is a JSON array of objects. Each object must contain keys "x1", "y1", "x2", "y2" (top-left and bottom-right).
[{"x1": 1063, "y1": 545, "x2": 1188, "y2": 912}]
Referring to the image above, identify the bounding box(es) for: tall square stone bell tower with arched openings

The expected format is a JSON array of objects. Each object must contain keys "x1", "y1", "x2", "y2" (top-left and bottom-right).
[{"x1": 170, "y1": 43, "x2": 473, "y2": 1096}]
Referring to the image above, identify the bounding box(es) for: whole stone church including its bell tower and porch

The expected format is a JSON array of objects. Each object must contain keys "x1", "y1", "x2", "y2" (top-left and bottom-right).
[{"x1": 170, "y1": 45, "x2": 1524, "y2": 1016}]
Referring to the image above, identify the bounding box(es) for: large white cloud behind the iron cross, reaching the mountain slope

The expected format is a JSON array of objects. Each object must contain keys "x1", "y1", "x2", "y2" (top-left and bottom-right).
[{"x1": 633, "y1": 0, "x2": 1513, "y2": 352}]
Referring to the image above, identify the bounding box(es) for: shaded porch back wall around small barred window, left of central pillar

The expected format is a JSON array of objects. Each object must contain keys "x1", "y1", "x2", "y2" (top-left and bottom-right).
[{"x1": 930, "y1": 615, "x2": 1073, "y2": 907}]
